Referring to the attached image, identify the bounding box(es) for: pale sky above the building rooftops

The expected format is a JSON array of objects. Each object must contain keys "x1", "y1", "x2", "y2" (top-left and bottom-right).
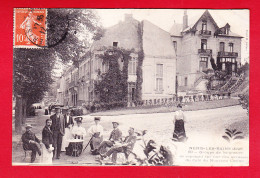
[{"x1": 96, "y1": 9, "x2": 249, "y2": 63}]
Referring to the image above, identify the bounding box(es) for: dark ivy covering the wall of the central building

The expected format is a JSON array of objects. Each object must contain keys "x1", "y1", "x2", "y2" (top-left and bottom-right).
[{"x1": 95, "y1": 47, "x2": 134, "y2": 108}]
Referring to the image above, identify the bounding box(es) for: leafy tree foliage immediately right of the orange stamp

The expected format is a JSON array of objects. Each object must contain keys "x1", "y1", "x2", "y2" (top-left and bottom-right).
[{"x1": 47, "y1": 9, "x2": 104, "y2": 66}]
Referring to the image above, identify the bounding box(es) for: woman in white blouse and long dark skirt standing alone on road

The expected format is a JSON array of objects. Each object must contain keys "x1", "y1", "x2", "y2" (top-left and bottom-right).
[{"x1": 173, "y1": 104, "x2": 187, "y2": 142}]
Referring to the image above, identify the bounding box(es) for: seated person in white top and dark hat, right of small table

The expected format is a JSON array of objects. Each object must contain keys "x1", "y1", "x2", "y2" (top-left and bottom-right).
[{"x1": 88, "y1": 117, "x2": 103, "y2": 155}]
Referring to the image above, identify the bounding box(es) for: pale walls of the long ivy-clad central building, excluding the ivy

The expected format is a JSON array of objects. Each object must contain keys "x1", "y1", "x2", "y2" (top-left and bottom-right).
[{"x1": 60, "y1": 14, "x2": 176, "y2": 106}]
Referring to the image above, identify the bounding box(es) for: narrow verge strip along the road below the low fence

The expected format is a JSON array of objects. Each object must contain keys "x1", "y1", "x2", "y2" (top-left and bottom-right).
[{"x1": 90, "y1": 98, "x2": 239, "y2": 116}]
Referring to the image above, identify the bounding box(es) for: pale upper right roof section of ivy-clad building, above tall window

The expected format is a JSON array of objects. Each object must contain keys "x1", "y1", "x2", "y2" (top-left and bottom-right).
[{"x1": 142, "y1": 20, "x2": 175, "y2": 58}]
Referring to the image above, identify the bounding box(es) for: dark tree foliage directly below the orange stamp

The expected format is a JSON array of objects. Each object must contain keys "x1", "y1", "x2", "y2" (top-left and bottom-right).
[{"x1": 13, "y1": 48, "x2": 54, "y2": 106}]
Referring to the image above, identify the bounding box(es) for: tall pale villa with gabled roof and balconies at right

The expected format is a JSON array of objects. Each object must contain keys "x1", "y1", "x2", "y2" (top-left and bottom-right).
[{"x1": 170, "y1": 10, "x2": 242, "y2": 91}]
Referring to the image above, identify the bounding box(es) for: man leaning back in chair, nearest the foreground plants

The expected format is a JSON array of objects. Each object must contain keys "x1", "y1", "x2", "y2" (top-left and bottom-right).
[{"x1": 100, "y1": 127, "x2": 136, "y2": 164}]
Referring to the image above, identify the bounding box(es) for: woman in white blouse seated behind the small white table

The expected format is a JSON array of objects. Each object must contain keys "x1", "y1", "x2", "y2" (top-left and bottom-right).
[{"x1": 66, "y1": 117, "x2": 87, "y2": 156}]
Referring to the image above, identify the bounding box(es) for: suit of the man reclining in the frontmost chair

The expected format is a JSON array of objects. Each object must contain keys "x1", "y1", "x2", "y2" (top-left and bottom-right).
[{"x1": 106, "y1": 135, "x2": 136, "y2": 164}]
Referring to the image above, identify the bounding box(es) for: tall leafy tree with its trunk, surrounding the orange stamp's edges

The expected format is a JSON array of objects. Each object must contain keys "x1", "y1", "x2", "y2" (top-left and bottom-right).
[{"x1": 13, "y1": 9, "x2": 103, "y2": 133}]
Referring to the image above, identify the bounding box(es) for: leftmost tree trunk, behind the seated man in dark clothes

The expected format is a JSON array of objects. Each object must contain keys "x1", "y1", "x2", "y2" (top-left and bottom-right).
[{"x1": 15, "y1": 96, "x2": 23, "y2": 134}]
